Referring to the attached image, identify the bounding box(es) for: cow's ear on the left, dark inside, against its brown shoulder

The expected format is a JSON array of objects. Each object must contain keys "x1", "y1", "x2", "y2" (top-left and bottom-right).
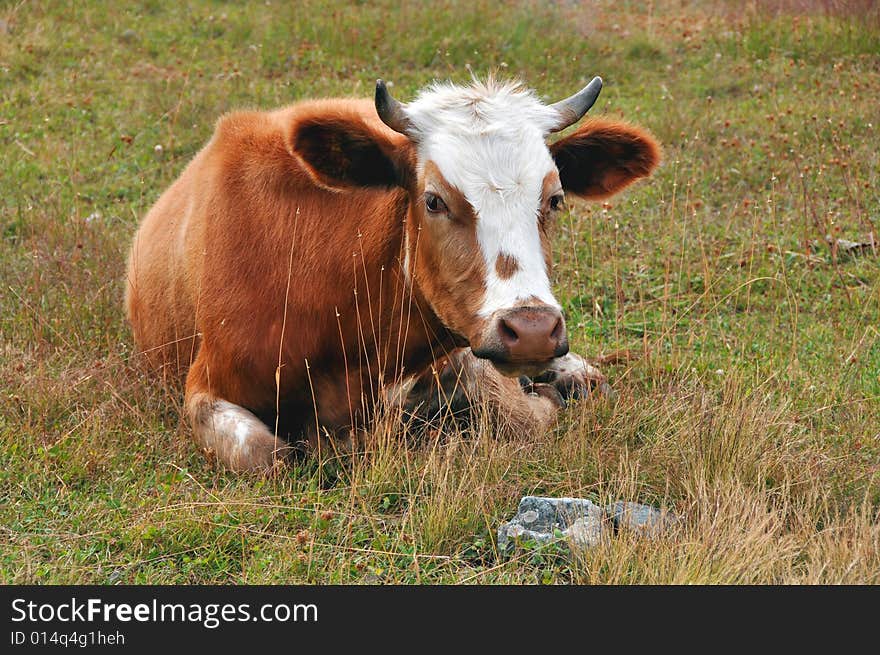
[{"x1": 291, "y1": 117, "x2": 411, "y2": 188}]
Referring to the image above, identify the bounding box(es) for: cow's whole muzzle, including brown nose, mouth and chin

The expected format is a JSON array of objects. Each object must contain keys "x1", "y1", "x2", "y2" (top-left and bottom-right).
[{"x1": 471, "y1": 305, "x2": 568, "y2": 375}]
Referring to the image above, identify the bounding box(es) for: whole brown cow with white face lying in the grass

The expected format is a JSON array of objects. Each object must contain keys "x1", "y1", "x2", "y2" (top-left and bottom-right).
[{"x1": 125, "y1": 77, "x2": 660, "y2": 471}]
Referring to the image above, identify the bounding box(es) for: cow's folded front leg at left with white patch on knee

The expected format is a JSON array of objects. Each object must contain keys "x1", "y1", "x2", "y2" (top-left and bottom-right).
[{"x1": 184, "y1": 357, "x2": 291, "y2": 472}]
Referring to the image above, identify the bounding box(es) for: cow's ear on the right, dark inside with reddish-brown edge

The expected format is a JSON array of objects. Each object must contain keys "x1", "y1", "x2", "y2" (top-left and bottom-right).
[{"x1": 550, "y1": 119, "x2": 660, "y2": 199}]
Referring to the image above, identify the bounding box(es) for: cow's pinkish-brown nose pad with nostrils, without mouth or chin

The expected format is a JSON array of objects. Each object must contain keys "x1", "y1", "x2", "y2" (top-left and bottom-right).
[{"x1": 496, "y1": 307, "x2": 568, "y2": 362}]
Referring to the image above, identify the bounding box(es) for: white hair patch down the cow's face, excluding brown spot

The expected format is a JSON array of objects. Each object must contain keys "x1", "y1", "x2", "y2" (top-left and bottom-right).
[{"x1": 407, "y1": 78, "x2": 559, "y2": 318}]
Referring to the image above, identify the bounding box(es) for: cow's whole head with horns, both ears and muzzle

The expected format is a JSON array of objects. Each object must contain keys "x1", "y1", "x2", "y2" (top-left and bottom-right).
[{"x1": 293, "y1": 77, "x2": 660, "y2": 375}]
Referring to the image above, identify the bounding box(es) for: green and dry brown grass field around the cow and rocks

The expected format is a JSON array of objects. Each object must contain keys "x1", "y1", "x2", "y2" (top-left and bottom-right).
[{"x1": 0, "y1": 0, "x2": 880, "y2": 584}]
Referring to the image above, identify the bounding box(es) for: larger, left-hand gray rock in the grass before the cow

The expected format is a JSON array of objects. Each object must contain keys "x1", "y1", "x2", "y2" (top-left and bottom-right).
[{"x1": 498, "y1": 496, "x2": 605, "y2": 552}]
